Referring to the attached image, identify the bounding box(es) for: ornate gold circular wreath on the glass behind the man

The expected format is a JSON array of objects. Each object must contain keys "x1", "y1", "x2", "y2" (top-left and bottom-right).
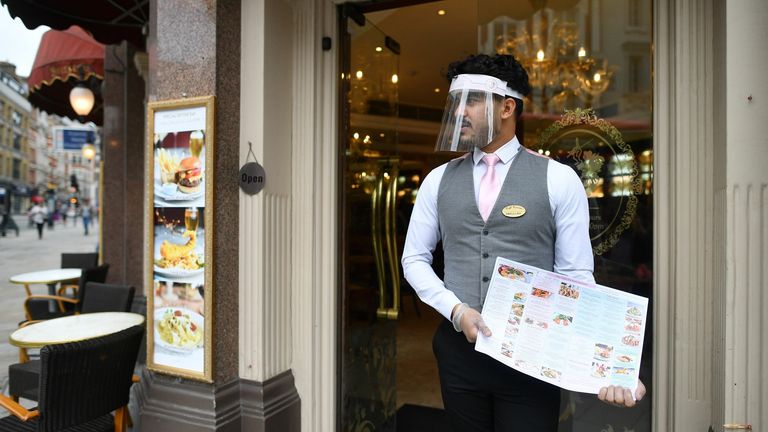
[{"x1": 539, "y1": 108, "x2": 642, "y2": 255}]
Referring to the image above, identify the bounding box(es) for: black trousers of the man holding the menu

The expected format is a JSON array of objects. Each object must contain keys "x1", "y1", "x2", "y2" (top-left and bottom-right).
[{"x1": 432, "y1": 320, "x2": 560, "y2": 432}]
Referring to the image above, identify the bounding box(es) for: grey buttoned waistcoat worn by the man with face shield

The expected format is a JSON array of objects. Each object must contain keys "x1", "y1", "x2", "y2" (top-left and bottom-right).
[{"x1": 437, "y1": 148, "x2": 555, "y2": 310}]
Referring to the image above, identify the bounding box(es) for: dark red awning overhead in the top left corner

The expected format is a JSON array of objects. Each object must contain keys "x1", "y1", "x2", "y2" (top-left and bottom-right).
[{"x1": 0, "y1": 0, "x2": 149, "y2": 49}]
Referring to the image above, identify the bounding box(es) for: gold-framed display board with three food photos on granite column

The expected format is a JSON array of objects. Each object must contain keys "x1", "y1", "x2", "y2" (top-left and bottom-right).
[{"x1": 146, "y1": 96, "x2": 214, "y2": 382}]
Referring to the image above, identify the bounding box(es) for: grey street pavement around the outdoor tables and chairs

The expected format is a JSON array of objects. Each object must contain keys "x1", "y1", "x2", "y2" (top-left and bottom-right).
[{"x1": 0, "y1": 215, "x2": 99, "y2": 398}]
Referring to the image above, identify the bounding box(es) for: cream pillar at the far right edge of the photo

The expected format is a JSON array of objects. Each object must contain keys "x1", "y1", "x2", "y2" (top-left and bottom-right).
[{"x1": 728, "y1": 0, "x2": 768, "y2": 431}]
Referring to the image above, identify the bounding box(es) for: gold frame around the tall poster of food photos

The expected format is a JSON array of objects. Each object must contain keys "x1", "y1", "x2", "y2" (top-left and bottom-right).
[{"x1": 144, "y1": 96, "x2": 215, "y2": 383}]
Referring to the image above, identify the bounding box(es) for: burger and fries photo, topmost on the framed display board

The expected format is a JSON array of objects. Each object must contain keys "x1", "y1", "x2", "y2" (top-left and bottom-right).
[{"x1": 154, "y1": 130, "x2": 205, "y2": 207}]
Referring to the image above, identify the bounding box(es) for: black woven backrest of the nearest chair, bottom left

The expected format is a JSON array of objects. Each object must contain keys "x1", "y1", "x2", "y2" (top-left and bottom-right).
[{"x1": 38, "y1": 326, "x2": 144, "y2": 431}]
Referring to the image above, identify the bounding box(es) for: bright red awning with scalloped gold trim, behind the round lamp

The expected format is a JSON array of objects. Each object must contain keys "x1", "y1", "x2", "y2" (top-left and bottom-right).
[{"x1": 28, "y1": 27, "x2": 104, "y2": 125}]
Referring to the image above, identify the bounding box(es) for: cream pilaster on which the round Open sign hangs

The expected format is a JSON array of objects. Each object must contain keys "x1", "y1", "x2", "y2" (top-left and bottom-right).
[{"x1": 242, "y1": 0, "x2": 297, "y2": 382}]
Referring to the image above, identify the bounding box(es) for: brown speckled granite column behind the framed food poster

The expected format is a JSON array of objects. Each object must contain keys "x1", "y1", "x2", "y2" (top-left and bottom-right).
[{"x1": 137, "y1": 0, "x2": 241, "y2": 432}]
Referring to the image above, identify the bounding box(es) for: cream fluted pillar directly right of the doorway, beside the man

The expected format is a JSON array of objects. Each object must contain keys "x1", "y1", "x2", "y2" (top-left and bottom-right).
[{"x1": 653, "y1": 0, "x2": 723, "y2": 431}]
